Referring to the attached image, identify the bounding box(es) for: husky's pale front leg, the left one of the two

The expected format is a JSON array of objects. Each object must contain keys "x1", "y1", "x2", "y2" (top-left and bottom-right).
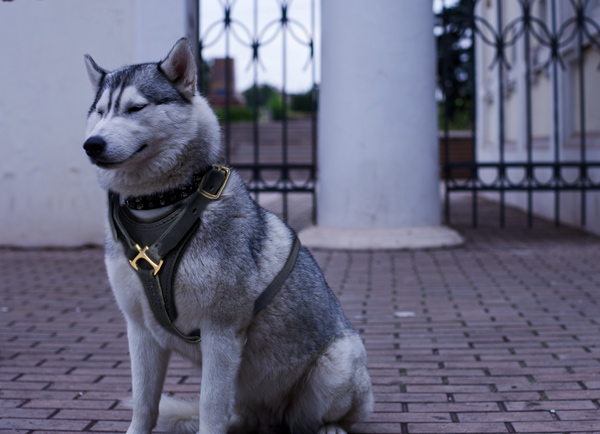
[{"x1": 127, "y1": 321, "x2": 170, "y2": 434}]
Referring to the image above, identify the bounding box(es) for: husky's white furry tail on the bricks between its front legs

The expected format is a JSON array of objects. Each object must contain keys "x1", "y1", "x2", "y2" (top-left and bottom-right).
[{"x1": 123, "y1": 395, "x2": 200, "y2": 434}]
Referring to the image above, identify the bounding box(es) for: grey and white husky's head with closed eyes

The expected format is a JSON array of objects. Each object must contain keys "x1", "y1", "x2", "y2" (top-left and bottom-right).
[{"x1": 83, "y1": 39, "x2": 220, "y2": 194}]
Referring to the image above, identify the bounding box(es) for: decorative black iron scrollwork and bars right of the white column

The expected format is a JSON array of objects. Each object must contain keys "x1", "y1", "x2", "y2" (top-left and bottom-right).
[{"x1": 438, "y1": 0, "x2": 600, "y2": 226}]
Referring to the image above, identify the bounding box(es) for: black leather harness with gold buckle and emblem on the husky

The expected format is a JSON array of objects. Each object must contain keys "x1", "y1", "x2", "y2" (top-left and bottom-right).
[{"x1": 108, "y1": 166, "x2": 300, "y2": 343}]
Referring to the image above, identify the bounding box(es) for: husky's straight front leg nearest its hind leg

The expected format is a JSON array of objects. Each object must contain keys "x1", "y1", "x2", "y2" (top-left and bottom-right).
[{"x1": 200, "y1": 327, "x2": 243, "y2": 434}]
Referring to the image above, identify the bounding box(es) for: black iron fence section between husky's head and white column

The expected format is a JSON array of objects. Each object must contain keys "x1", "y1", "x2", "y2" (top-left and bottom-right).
[{"x1": 188, "y1": 0, "x2": 318, "y2": 220}]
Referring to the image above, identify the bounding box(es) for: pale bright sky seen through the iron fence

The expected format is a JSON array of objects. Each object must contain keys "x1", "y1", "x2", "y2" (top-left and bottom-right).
[{"x1": 200, "y1": 0, "x2": 458, "y2": 93}]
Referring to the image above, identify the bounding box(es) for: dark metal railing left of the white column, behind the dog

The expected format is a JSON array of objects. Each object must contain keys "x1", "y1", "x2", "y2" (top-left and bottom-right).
[{"x1": 188, "y1": 0, "x2": 317, "y2": 221}]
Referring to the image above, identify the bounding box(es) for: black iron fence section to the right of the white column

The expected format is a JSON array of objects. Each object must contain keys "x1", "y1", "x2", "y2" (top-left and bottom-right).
[{"x1": 436, "y1": 0, "x2": 600, "y2": 226}]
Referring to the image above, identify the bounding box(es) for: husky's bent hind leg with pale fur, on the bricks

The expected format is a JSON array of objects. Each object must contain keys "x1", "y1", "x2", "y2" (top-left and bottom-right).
[{"x1": 287, "y1": 334, "x2": 373, "y2": 434}]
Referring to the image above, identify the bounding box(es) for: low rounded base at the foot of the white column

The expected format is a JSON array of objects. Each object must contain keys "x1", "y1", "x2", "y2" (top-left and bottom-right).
[{"x1": 298, "y1": 226, "x2": 464, "y2": 250}]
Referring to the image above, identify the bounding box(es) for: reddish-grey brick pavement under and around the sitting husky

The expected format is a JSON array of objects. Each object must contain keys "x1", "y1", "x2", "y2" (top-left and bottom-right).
[{"x1": 0, "y1": 195, "x2": 600, "y2": 434}]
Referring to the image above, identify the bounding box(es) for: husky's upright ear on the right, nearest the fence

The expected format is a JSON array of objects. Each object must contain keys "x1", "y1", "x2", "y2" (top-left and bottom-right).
[{"x1": 158, "y1": 38, "x2": 196, "y2": 99}]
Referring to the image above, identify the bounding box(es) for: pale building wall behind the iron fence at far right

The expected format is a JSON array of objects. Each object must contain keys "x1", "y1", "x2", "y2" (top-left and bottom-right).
[{"x1": 475, "y1": 0, "x2": 600, "y2": 233}]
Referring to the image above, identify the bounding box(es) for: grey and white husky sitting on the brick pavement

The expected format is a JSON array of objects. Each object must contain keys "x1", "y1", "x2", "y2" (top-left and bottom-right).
[{"x1": 84, "y1": 39, "x2": 373, "y2": 434}]
